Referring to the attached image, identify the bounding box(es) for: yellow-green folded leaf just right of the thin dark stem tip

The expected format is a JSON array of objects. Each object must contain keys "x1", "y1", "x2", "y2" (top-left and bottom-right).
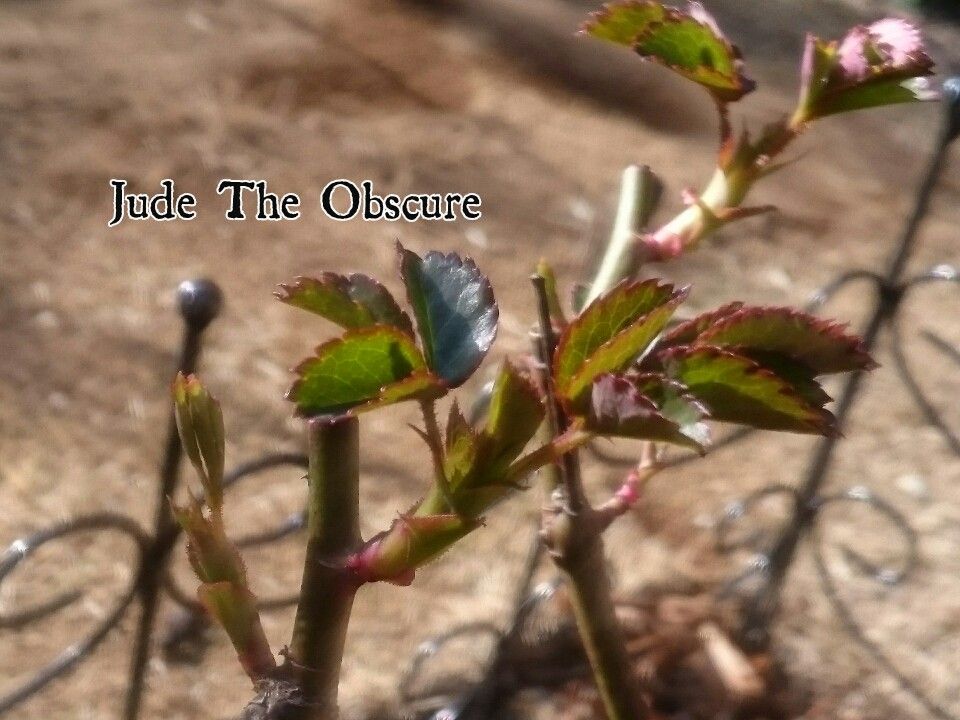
[{"x1": 553, "y1": 280, "x2": 687, "y2": 405}]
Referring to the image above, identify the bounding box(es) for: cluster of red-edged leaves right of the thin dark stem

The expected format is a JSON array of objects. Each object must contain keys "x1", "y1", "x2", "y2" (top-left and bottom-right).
[{"x1": 553, "y1": 280, "x2": 874, "y2": 452}]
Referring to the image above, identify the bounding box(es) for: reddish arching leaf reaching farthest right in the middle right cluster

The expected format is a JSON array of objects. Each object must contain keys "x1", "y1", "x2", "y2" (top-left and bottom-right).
[{"x1": 695, "y1": 307, "x2": 876, "y2": 375}]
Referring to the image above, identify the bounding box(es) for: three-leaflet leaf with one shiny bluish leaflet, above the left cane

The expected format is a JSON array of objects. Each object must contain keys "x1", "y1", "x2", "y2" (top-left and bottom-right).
[{"x1": 276, "y1": 244, "x2": 498, "y2": 416}]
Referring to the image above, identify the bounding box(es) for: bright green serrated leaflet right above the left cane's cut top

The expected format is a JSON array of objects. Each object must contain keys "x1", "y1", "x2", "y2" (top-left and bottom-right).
[{"x1": 287, "y1": 325, "x2": 426, "y2": 415}]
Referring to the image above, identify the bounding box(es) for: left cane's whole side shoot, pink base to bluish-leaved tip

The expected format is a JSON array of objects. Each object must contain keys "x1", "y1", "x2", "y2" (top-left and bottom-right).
[{"x1": 277, "y1": 244, "x2": 586, "y2": 584}]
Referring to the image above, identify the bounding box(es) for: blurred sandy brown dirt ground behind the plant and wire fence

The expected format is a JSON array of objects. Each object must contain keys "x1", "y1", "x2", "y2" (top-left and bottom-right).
[{"x1": 0, "y1": 0, "x2": 960, "y2": 720}]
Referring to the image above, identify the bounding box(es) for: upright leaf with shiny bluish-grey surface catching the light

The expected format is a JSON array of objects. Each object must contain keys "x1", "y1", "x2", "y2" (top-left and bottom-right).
[{"x1": 397, "y1": 243, "x2": 499, "y2": 387}]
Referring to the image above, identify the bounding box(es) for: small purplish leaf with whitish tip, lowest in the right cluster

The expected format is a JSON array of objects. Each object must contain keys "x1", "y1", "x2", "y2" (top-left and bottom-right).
[{"x1": 586, "y1": 375, "x2": 704, "y2": 453}]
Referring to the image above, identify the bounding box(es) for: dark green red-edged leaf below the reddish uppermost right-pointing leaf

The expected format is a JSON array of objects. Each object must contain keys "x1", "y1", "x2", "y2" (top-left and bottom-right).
[{"x1": 661, "y1": 346, "x2": 836, "y2": 435}]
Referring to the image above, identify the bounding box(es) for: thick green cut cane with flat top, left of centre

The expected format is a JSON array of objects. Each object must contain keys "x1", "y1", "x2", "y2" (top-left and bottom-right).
[{"x1": 289, "y1": 417, "x2": 362, "y2": 720}]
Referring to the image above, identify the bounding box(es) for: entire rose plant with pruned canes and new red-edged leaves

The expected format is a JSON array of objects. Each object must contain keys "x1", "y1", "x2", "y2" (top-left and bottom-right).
[{"x1": 174, "y1": 0, "x2": 933, "y2": 720}]
